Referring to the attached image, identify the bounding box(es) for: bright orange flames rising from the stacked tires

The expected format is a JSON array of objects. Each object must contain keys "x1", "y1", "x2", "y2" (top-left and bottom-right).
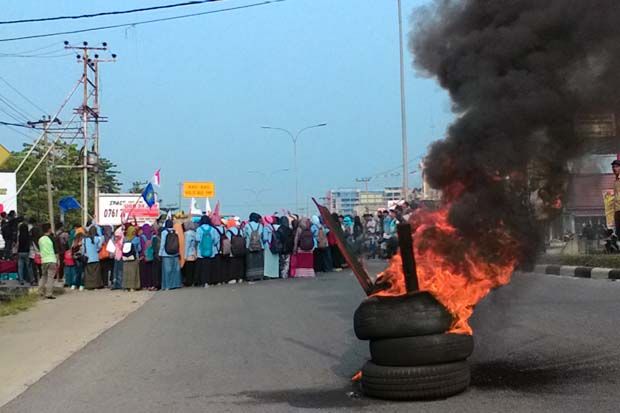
[{"x1": 374, "y1": 205, "x2": 517, "y2": 335}]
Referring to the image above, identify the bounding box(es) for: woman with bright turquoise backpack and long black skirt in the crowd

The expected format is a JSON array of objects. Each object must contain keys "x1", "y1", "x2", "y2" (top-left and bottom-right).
[{"x1": 196, "y1": 215, "x2": 220, "y2": 288}]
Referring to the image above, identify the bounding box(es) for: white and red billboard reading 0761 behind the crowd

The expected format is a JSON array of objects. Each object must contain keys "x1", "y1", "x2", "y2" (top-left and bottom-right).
[{"x1": 97, "y1": 194, "x2": 160, "y2": 226}]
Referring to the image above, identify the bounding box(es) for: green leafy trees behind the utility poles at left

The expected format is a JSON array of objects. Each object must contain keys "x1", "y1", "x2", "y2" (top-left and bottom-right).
[{"x1": 0, "y1": 143, "x2": 121, "y2": 222}]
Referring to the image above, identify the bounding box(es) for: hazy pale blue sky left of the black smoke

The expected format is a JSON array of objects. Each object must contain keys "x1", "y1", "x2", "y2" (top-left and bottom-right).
[{"x1": 0, "y1": 0, "x2": 452, "y2": 214}]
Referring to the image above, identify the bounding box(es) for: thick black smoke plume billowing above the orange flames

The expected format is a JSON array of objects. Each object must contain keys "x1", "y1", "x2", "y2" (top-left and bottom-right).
[{"x1": 409, "y1": 0, "x2": 620, "y2": 262}]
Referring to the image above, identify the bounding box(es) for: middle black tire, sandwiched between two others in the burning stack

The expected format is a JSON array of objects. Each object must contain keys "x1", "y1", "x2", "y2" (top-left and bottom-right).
[{"x1": 370, "y1": 334, "x2": 474, "y2": 367}]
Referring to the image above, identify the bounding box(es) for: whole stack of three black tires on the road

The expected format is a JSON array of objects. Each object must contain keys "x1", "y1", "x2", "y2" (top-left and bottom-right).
[{"x1": 354, "y1": 292, "x2": 474, "y2": 400}]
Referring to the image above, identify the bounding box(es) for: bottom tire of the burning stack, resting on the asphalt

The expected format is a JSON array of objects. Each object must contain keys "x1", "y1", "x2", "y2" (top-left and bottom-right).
[{"x1": 362, "y1": 361, "x2": 471, "y2": 400}]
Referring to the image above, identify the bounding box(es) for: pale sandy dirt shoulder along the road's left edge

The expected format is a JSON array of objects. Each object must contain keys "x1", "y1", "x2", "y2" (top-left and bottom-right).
[{"x1": 0, "y1": 284, "x2": 153, "y2": 407}]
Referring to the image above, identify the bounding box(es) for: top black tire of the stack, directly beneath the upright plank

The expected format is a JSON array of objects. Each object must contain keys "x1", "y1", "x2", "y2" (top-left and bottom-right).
[{"x1": 353, "y1": 292, "x2": 452, "y2": 340}]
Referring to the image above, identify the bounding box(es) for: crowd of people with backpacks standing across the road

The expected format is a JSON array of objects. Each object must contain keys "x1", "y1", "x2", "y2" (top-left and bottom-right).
[{"x1": 2, "y1": 202, "x2": 416, "y2": 298}]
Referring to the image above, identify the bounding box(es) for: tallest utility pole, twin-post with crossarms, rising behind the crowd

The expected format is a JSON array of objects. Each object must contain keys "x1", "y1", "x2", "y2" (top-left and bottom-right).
[{"x1": 65, "y1": 41, "x2": 116, "y2": 225}]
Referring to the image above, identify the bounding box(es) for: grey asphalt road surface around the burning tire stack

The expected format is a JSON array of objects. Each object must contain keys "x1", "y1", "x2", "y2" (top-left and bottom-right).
[{"x1": 0, "y1": 264, "x2": 620, "y2": 413}]
